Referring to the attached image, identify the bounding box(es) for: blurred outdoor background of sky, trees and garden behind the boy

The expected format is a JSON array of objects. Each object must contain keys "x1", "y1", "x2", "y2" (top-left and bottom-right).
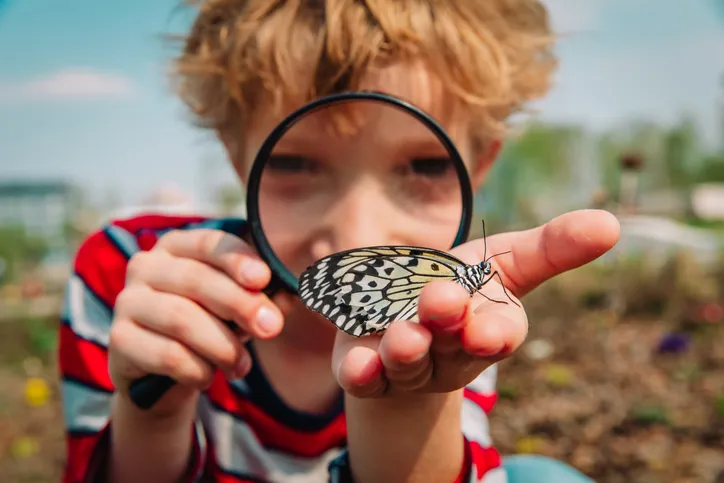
[{"x1": 0, "y1": 0, "x2": 724, "y2": 482}]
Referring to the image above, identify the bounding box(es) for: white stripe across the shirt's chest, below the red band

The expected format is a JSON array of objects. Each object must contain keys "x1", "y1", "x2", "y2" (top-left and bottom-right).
[{"x1": 199, "y1": 396, "x2": 342, "y2": 483}]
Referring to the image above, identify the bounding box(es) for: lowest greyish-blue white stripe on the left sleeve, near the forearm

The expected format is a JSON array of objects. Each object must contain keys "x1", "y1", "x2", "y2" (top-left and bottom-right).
[{"x1": 61, "y1": 381, "x2": 112, "y2": 433}]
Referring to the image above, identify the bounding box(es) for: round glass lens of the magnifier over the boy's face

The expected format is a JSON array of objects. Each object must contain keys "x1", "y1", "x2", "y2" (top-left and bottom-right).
[{"x1": 258, "y1": 100, "x2": 463, "y2": 277}]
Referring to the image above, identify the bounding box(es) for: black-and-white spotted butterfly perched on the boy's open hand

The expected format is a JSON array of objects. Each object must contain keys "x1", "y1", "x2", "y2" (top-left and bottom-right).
[{"x1": 299, "y1": 221, "x2": 520, "y2": 337}]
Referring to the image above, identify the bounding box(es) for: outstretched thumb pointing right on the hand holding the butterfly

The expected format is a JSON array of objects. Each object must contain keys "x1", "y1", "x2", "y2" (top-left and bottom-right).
[{"x1": 453, "y1": 210, "x2": 620, "y2": 298}]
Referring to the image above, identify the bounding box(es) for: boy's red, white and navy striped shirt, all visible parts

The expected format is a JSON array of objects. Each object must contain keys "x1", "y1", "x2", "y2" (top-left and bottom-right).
[{"x1": 59, "y1": 215, "x2": 506, "y2": 483}]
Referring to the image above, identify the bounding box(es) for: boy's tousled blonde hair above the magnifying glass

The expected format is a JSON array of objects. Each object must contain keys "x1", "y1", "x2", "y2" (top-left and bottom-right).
[{"x1": 173, "y1": 0, "x2": 556, "y2": 153}]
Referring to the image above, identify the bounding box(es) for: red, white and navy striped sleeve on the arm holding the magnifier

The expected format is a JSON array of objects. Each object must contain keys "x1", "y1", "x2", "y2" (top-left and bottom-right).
[{"x1": 58, "y1": 225, "x2": 206, "y2": 483}]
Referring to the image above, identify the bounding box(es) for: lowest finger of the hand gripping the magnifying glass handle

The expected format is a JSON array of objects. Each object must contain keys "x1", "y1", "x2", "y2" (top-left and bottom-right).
[{"x1": 110, "y1": 318, "x2": 221, "y2": 390}]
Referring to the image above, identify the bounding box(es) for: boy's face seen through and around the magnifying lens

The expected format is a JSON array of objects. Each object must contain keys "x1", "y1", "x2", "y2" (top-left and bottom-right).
[{"x1": 228, "y1": 67, "x2": 496, "y2": 334}]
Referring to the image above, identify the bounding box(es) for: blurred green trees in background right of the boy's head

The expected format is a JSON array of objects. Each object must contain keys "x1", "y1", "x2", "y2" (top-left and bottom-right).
[{"x1": 476, "y1": 112, "x2": 724, "y2": 229}]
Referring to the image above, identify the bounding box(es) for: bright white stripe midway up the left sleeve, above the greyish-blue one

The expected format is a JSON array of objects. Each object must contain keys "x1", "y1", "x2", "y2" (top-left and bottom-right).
[{"x1": 63, "y1": 274, "x2": 113, "y2": 347}]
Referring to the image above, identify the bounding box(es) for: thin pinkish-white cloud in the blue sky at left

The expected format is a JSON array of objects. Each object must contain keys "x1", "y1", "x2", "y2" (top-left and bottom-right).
[{"x1": 0, "y1": 67, "x2": 134, "y2": 102}]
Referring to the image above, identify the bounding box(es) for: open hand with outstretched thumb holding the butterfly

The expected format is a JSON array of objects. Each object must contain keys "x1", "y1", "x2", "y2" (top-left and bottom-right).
[{"x1": 333, "y1": 210, "x2": 620, "y2": 398}]
